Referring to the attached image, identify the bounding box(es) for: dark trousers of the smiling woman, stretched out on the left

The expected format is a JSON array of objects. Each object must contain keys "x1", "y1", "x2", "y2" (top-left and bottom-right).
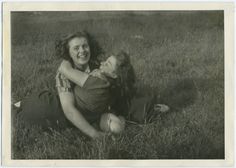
[{"x1": 19, "y1": 91, "x2": 73, "y2": 129}]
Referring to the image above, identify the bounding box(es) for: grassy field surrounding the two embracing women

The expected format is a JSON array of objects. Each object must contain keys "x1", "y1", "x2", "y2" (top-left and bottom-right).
[{"x1": 11, "y1": 11, "x2": 224, "y2": 159}]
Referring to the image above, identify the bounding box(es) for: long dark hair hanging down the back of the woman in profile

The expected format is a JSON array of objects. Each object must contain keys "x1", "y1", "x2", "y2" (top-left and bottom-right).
[{"x1": 113, "y1": 51, "x2": 136, "y2": 116}]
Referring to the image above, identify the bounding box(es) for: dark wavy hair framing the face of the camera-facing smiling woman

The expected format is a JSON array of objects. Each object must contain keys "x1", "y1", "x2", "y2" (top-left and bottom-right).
[{"x1": 55, "y1": 31, "x2": 103, "y2": 69}]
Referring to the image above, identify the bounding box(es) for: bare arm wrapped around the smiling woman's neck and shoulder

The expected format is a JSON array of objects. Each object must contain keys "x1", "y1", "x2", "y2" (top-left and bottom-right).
[{"x1": 58, "y1": 60, "x2": 89, "y2": 87}]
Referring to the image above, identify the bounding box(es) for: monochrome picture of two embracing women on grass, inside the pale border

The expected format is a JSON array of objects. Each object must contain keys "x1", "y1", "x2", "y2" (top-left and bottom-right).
[{"x1": 3, "y1": 1, "x2": 233, "y2": 167}]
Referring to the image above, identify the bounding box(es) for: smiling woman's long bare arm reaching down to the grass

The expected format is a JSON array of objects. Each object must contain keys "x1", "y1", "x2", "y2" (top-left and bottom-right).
[{"x1": 59, "y1": 92, "x2": 102, "y2": 138}]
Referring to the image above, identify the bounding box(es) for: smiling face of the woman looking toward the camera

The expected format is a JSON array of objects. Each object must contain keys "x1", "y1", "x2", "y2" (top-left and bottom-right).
[{"x1": 68, "y1": 37, "x2": 91, "y2": 67}]
